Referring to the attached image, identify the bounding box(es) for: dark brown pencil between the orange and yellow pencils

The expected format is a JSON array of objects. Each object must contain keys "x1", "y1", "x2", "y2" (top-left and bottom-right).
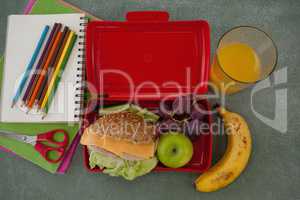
[{"x1": 36, "y1": 26, "x2": 69, "y2": 106}]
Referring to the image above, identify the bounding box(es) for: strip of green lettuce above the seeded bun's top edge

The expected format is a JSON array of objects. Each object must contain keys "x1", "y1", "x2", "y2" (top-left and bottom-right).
[{"x1": 99, "y1": 104, "x2": 159, "y2": 122}]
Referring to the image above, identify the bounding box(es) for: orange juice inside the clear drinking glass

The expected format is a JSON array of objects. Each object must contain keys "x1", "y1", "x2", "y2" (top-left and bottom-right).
[{"x1": 210, "y1": 43, "x2": 261, "y2": 94}]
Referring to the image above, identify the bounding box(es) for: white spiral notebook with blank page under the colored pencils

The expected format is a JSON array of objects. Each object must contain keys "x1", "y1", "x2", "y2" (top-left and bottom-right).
[{"x1": 0, "y1": 14, "x2": 86, "y2": 122}]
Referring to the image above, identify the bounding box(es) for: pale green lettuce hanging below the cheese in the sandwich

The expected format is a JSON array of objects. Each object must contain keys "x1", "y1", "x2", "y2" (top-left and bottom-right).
[{"x1": 89, "y1": 151, "x2": 158, "y2": 180}]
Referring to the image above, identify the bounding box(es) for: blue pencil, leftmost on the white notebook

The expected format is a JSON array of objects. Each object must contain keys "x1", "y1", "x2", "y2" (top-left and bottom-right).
[{"x1": 11, "y1": 25, "x2": 49, "y2": 107}]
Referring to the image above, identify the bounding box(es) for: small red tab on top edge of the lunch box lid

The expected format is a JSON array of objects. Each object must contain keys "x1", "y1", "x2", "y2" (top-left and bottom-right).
[{"x1": 126, "y1": 11, "x2": 169, "y2": 21}]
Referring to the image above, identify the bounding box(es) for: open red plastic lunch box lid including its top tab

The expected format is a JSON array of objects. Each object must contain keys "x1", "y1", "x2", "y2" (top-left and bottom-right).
[{"x1": 86, "y1": 11, "x2": 210, "y2": 100}]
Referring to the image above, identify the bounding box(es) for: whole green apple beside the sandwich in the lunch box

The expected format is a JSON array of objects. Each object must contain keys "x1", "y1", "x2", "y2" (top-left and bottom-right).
[{"x1": 157, "y1": 132, "x2": 193, "y2": 168}]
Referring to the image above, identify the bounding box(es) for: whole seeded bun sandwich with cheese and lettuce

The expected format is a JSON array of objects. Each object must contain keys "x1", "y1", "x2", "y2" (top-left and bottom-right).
[{"x1": 80, "y1": 104, "x2": 159, "y2": 180}]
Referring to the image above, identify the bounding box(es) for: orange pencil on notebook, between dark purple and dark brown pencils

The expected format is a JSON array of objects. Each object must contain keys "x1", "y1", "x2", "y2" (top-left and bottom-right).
[{"x1": 27, "y1": 31, "x2": 62, "y2": 109}]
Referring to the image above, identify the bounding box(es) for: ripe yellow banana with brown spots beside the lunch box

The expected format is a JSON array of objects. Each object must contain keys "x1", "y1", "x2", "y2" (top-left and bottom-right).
[{"x1": 195, "y1": 107, "x2": 252, "y2": 192}]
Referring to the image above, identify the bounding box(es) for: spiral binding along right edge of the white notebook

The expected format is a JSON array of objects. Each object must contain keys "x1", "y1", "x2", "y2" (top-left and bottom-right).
[{"x1": 74, "y1": 16, "x2": 88, "y2": 121}]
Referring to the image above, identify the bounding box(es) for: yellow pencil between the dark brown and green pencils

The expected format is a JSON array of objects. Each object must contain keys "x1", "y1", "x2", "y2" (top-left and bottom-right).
[{"x1": 41, "y1": 31, "x2": 75, "y2": 110}]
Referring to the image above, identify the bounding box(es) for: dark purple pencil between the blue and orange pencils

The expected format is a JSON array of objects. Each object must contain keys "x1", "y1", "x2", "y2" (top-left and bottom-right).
[{"x1": 22, "y1": 23, "x2": 58, "y2": 103}]
